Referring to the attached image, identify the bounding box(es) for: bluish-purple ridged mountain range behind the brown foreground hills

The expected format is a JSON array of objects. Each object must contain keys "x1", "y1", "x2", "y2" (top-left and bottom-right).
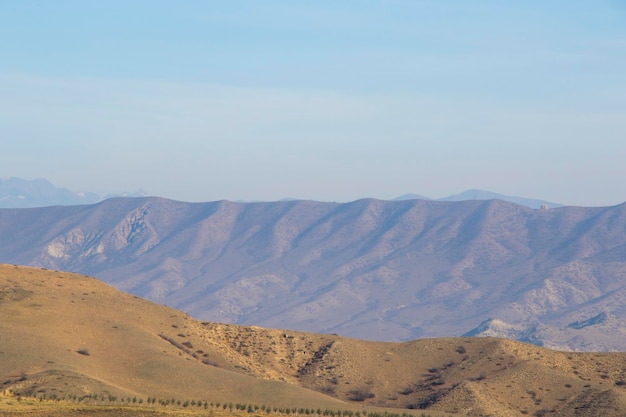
[{"x1": 0, "y1": 198, "x2": 626, "y2": 350}]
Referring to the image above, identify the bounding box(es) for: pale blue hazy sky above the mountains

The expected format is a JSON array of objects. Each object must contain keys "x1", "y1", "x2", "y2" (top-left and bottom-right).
[{"x1": 0, "y1": 0, "x2": 626, "y2": 205}]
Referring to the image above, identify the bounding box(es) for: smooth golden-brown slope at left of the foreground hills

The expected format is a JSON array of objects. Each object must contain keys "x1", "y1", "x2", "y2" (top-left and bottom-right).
[{"x1": 0, "y1": 266, "x2": 338, "y2": 405}]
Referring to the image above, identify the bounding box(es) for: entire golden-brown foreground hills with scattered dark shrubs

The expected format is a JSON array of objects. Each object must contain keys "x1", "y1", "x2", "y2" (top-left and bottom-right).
[{"x1": 0, "y1": 265, "x2": 626, "y2": 416}]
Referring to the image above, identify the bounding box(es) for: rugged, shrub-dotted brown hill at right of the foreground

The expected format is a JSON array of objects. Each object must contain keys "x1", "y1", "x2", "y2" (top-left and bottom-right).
[{"x1": 192, "y1": 323, "x2": 626, "y2": 416}]
